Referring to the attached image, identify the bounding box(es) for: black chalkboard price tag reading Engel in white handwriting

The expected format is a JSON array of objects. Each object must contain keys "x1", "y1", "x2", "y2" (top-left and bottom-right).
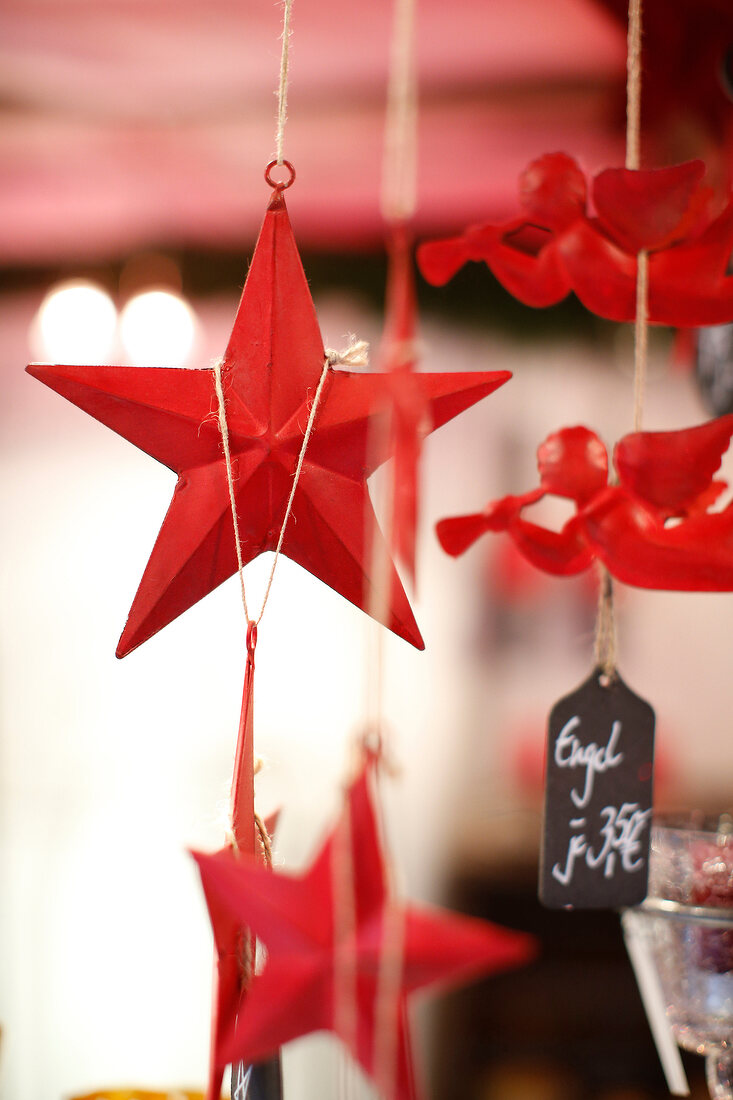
[{"x1": 539, "y1": 669, "x2": 654, "y2": 909}]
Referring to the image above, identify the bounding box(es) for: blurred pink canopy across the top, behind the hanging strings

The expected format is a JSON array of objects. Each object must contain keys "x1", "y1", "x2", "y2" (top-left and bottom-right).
[{"x1": 0, "y1": 0, "x2": 625, "y2": 263}]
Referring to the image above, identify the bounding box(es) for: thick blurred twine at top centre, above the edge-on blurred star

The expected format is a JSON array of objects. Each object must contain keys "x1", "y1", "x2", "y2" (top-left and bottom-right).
[{"x1": 381, "y1": 0, "x2": 417, "y2": 221}]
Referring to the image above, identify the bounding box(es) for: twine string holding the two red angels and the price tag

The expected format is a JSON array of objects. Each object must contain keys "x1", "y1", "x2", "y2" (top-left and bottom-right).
[{"x1": 594, "y1": 0, "x2": 649, "y2": 679}]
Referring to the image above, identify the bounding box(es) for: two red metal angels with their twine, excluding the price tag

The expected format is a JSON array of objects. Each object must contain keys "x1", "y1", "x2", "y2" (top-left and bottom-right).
[{"x1": 418, "y1": 0, "x2": 733, "y2": 607}]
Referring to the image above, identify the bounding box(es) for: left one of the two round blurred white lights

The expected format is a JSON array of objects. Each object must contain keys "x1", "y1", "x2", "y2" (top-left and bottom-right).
[{"x1": 29, "y1": 282, "x2": 117, "y2": 363}]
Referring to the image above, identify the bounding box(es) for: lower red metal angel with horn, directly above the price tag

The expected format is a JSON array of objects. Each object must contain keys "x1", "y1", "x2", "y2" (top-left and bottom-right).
[{"x1": 437, "y1": 415, "x2": 733, "y2": 592}]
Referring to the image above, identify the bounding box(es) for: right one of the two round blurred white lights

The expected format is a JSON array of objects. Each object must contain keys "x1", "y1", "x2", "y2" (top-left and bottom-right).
[{"x1": 120, "y1": 290, "x2": 196, "y2": 366}]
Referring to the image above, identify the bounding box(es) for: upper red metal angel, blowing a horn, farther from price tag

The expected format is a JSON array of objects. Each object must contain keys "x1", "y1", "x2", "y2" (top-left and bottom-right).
[{"x1": 418, "y1": 153, "x2": 733, "y2": 327}]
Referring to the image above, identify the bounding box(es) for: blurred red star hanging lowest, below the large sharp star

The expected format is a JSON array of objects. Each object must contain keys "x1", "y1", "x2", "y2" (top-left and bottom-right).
[{"x1": 195, "y1": 769, "x2": 534, "y2": 1100}]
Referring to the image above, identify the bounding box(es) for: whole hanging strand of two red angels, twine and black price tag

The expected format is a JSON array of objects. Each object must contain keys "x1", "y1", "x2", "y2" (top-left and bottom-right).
[{"x1": 419, "y1": 0, "x2": 717, "y2": 908}]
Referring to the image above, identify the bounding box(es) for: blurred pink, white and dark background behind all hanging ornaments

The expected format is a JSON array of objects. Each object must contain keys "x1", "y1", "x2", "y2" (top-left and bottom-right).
[{"x1": 0, "y1": 0, "x2": 733, "y2": 1100}]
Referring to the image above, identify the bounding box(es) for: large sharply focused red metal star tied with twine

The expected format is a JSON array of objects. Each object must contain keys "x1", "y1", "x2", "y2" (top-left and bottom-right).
[{"x1": 28, "y1": 188, "x2": 511, "y2": 657}]
